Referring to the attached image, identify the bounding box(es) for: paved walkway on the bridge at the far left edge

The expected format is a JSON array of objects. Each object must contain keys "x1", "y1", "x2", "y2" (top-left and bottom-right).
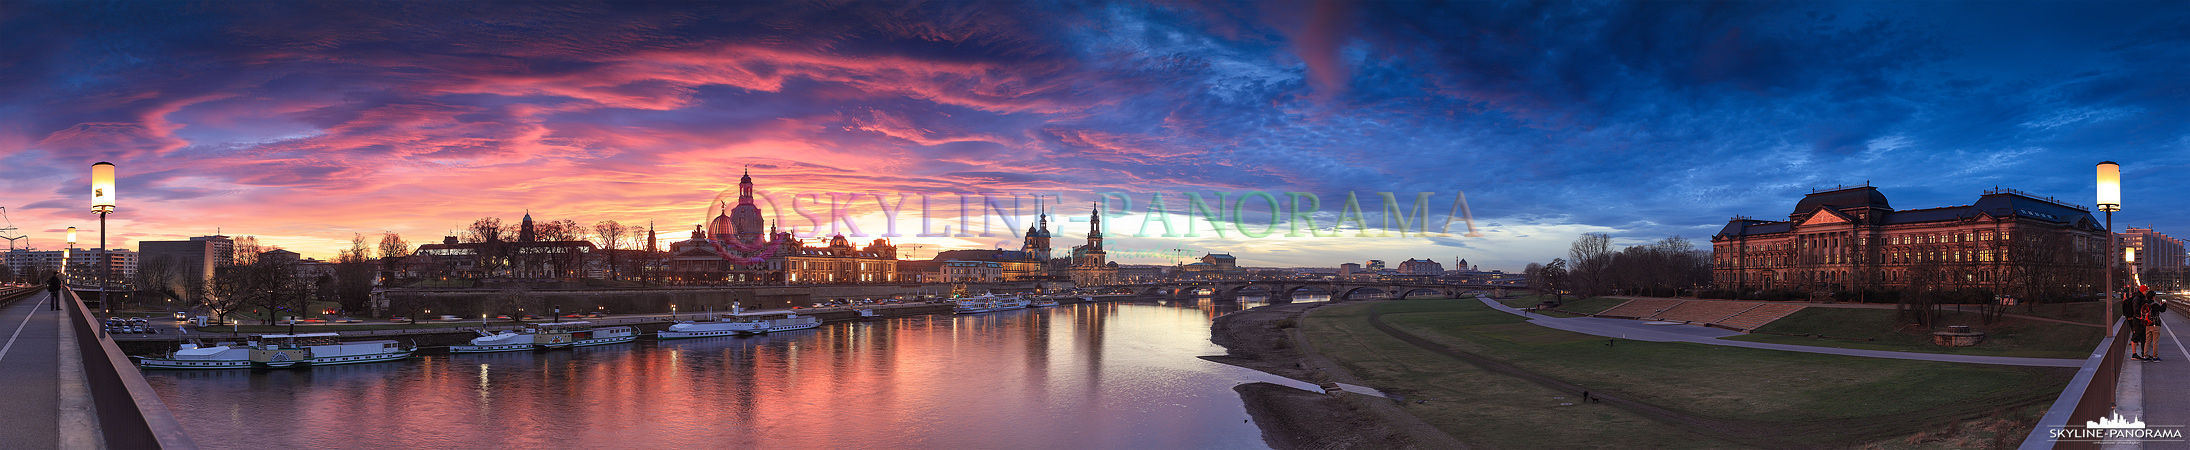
[{"x1": 0, "y1": 292, "x2": 61, "y2": 448}]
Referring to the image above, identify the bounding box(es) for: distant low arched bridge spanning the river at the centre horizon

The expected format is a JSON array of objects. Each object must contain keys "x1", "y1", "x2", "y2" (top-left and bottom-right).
[{"x1": 1104, "y1": 279, "x2": 1511, "y2": 303}]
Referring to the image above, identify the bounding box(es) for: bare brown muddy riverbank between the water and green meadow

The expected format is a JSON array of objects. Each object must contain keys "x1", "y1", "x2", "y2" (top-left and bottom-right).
[{"x1": 1202, "y1": 303, "x2": 1465, "y2": 450}]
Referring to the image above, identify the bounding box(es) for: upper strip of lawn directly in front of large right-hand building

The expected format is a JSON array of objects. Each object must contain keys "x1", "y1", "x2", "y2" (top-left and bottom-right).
[{"x1": 1728, "y1": 307, "x2": 2105, "y2": 358}]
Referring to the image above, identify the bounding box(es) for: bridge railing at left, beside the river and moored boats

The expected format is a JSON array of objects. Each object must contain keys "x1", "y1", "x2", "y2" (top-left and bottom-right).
[{"x1": 61, "y1": 290, "x2": 197, "y2": 450}]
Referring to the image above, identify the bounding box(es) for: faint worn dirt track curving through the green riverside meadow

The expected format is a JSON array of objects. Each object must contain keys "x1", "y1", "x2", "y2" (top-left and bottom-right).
[{"x1": 1369, "y1": 307, "x2": 2052, "y2": 448}]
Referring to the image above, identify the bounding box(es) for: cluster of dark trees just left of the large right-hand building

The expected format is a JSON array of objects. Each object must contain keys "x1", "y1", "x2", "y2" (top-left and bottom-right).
[{"x1": 1522, "y1": 233, "x2": 1710, "y2": 301}]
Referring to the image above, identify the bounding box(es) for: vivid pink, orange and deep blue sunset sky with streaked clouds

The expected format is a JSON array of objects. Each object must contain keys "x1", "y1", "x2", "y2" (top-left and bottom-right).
[{"x1": 0, "y1": 2, "x2": 2190, "y2": 270}]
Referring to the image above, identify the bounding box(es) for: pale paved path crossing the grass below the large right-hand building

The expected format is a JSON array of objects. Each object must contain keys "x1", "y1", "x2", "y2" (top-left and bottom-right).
[{"x1": 1476, "y1": 296, "x2": 2076, "y2": 366}]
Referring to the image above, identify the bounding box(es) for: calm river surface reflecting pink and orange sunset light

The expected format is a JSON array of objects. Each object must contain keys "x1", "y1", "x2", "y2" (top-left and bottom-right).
[{"x1": 145, "y1": 301, "x2": 1322, "y2": 448}]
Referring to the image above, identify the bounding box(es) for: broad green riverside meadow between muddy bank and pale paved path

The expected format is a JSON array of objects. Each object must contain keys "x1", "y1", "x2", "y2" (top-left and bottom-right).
[{"x1": 1303, "y1": 301, "x2": 2074, "y2": 448}]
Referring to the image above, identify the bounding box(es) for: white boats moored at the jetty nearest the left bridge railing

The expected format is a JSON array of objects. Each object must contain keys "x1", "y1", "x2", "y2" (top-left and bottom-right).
[{"x1": 138, "y1": 334, "x2": 412, "y2": 369}]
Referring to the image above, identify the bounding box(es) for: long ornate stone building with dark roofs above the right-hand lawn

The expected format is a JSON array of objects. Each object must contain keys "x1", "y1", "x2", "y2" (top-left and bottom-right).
[{"x1": 1710, "y1": 184, "x2": 2107, "y2": 296}]
